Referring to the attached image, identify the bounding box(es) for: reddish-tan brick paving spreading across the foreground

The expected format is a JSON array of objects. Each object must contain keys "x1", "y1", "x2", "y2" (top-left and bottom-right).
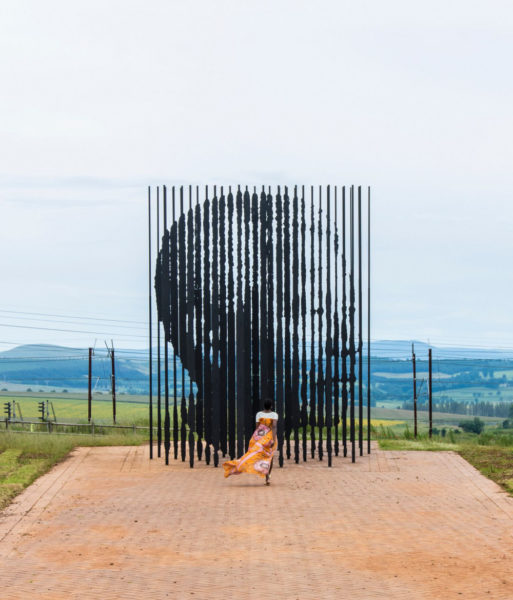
[{"x1": 0, "y1": 447, "x2": 513, "y2": 600}]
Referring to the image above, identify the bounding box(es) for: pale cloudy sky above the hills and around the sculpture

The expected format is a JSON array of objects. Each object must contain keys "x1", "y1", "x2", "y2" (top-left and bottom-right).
[{"x1": 0, "y1": 0, "x2": 513, "y2": 350}]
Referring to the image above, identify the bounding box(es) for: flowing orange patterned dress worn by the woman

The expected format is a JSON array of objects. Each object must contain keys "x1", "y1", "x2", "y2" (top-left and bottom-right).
[{"x1": 223, "y1": 418, "x2": 277, "y2": 477}]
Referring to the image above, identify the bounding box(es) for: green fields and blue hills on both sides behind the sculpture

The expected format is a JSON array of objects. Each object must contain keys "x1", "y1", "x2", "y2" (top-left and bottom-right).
[{"x1": 0, "y1": 342, "x2": 513, "y2": 507}]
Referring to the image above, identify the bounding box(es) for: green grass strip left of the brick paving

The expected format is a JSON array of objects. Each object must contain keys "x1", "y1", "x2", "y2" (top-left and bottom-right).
[{"x1": 0, "y1": 432, "x2": 146, "y2": 510}]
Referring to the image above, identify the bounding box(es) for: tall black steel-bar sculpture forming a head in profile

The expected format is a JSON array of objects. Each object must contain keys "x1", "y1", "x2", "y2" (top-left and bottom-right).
[{"x1": 148, "y1": 186, "x2": 371, "y2": 467}]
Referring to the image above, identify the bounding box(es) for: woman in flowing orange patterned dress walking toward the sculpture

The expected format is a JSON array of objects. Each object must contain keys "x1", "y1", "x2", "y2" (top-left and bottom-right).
[{"x1": 223, "y1": 399, "x2": 278, "y2": 485}]
